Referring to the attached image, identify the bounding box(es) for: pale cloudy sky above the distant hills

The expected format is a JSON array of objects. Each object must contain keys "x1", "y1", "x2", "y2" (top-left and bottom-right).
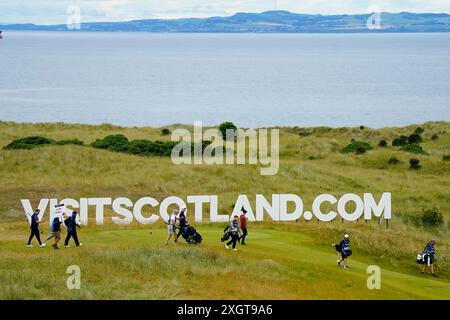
[{"x1": 0, "y1": 0, "x2": 450, "y2": 24}]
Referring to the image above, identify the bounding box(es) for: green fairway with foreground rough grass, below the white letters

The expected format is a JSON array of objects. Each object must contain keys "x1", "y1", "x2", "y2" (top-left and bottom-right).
[{"x1": 0, "y1": 225, "x2": 450, "y2": 299}]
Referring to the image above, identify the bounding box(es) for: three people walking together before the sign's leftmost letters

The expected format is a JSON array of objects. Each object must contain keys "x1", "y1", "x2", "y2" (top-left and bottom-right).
[{"x1": 27, "y1": 209, "x2": 83, "y2": 249}]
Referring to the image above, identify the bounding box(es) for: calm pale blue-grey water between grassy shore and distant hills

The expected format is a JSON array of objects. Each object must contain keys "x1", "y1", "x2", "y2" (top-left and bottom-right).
[{"x1": 0, "y1": 32, "x2": 450, "y2": 127}]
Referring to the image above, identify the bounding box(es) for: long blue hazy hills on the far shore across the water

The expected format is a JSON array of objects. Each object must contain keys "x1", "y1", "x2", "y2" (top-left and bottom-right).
[{"x1": 0, "y1": 11, "x2": 450, "y2": 33}]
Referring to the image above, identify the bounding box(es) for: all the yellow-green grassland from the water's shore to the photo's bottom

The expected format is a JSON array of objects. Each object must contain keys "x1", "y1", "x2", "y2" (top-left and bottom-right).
[{"x1": 0, "y1": 122, "x2": 450, "y2": 299}]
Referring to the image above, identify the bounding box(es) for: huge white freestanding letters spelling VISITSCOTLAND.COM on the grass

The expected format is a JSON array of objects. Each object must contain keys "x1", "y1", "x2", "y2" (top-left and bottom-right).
[{"x1": 21, "y1": 192, "x2": 391, "y2": 225}]
